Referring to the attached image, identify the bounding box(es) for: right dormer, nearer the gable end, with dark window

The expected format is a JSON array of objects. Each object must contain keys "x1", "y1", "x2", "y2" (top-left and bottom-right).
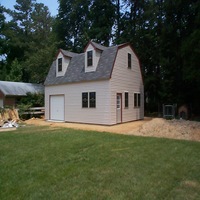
[{"x1": 84, "y1": 41, "x2": 106, "y2": 72}]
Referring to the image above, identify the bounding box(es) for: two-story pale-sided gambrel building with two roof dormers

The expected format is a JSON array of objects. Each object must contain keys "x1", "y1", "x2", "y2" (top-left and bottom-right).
[{"x1": 45, "y1": 41, "x2": 144, "y2": 125}]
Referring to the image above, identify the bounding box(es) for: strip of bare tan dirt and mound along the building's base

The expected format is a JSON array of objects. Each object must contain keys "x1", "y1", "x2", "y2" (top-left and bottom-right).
[{"x1": 25, "y1": 118, "x2": 200, "y2": 141}]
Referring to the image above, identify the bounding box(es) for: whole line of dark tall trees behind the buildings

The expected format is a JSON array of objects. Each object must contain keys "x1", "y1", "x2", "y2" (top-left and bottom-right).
[{"x1": 0, "y1": 0, "x2": 200, "y2": 115}]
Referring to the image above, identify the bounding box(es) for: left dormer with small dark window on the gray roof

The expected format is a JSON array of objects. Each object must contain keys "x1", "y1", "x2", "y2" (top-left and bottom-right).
[{"x1": 56, "y1": 49, "x2": 76, "y2": 77}]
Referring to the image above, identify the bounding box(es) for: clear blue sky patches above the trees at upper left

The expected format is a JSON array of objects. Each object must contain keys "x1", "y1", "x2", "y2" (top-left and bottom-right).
[{"x1": 0, "y1": 0, "x2": 58, "y2": 16}]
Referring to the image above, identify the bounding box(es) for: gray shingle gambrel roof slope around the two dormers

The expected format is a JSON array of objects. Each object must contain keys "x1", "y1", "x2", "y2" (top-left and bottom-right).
[{"x1": 44, "y1": 42, "x2": 119, "y2": 85}]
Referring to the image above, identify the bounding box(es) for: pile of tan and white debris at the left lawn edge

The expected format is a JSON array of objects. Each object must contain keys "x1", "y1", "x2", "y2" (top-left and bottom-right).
[{"x1": 0, "y1": 109, "x2": 19, "y2": 128}]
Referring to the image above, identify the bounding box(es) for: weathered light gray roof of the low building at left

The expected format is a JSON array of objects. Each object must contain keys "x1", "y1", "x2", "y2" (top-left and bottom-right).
[{"x1": 0, "y1": 81, "x2": 44, "y2": 96}]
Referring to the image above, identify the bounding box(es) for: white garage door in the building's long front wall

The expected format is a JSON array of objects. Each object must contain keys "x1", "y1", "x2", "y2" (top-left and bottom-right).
[{"x1": 50, "y1": 95, "x2": 64, "y2": 121}]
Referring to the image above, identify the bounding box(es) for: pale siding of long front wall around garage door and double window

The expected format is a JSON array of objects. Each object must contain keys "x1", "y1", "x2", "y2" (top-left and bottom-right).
[{"x1": 45, "y1": 80, "x2": 111, "y2": 125}]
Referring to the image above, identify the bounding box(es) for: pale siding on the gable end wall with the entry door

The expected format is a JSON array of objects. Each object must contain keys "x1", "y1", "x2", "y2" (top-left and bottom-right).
[{"x1": 110, "y1": 46, "x2": 144, "y2": 123}]
